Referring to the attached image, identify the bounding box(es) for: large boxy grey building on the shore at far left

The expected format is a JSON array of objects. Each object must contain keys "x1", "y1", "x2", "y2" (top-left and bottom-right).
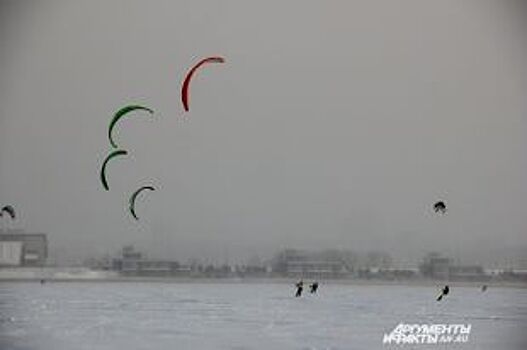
[{"x1": 0, "y1": 230, "x2": 48, "y2": 267}]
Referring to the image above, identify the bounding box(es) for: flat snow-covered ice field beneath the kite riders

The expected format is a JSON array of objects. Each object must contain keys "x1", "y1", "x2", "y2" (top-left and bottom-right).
[{"x1": 0, "y1": 282, "x2": 527, "y2": 350}]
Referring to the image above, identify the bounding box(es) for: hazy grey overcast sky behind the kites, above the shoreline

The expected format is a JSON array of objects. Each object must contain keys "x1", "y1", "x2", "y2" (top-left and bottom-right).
[{"x1": 0, "y1": 0, "x2": 527, "y2": 267}]
